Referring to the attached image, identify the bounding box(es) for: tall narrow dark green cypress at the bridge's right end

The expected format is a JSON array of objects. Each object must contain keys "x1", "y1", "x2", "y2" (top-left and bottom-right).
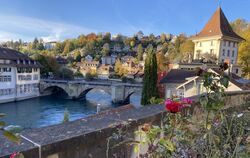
[{"x1": 141, "y1": 46, "x2": 159, "y2": 105}]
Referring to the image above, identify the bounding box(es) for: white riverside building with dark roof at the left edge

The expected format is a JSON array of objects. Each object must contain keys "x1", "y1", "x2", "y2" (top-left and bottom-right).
[{"x1": 0, "y1": 48, "x2": 41, "y2": 103}]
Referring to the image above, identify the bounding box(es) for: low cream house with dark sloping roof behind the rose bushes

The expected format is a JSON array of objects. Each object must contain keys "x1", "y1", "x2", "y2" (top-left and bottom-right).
[{"x1": 160, "y1": 69, "x2": 250, "y2": 98}]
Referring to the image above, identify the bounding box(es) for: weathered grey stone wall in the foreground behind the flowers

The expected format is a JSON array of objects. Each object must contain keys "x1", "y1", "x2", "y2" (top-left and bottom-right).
[{"x1": 0, "y1": 91, "x2": 250, "y2": 158}]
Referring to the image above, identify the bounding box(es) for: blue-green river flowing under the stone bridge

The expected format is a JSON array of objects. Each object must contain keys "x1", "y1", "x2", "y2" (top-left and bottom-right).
[{"x1": 0, "y1": 91, "x2": 140, "y2": 129}]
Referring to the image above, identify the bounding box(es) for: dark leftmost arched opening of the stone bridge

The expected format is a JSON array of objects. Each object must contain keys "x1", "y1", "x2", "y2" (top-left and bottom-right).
[{"x1": 41, "y1": 86, "x2": 69, "y2": 99}]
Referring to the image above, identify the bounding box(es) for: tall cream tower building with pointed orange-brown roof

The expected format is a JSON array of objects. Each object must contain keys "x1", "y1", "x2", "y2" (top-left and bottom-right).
[{"x1": 185, "y1": 7, "x2": 244, "y2": 76}]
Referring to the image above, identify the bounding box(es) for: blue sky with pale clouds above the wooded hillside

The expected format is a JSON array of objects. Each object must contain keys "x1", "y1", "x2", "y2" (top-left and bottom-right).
[{"x1": 0, "y1": 0, "x2": 250, "y2": 41}]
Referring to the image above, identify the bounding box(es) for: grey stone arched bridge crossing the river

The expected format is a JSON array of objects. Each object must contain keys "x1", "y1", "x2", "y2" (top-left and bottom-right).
[{"x1": 40, "y1": 79, "x2": 142, "y2": 103}]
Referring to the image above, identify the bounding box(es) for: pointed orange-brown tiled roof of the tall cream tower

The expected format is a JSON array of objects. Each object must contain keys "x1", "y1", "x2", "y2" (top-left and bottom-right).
[{"x1": 194, "y1": 7, "x2": 244, "y2": 41}]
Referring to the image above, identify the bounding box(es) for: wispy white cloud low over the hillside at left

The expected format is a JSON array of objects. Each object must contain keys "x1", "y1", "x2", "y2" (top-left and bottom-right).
[{"x1": 0, "y1": 15, "x2": 96, "y2": 41}]
